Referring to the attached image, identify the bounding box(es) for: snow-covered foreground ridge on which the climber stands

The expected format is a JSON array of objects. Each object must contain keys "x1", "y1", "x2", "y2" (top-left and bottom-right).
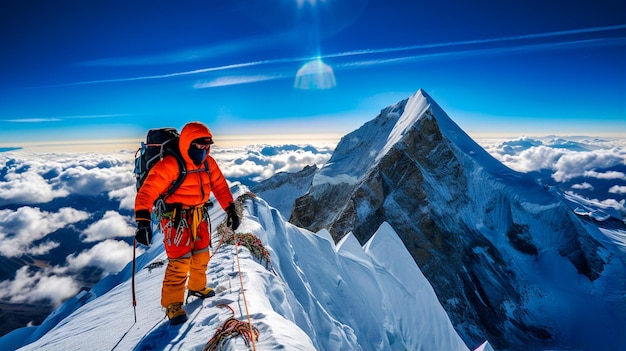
[{"x1": 0, "y1": 186, "x2": 467, "y2": 351}]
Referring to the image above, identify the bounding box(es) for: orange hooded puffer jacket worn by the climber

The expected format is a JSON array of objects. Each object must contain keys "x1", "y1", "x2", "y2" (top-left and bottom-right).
[{"x1": 135, "y1": 122, "x2": 234, "y2": 219}]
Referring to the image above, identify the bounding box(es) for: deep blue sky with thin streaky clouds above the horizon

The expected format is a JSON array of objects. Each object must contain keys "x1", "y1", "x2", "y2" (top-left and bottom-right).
[{"x1": 0, "y1": 0, "x2": 626, "y2": 146}]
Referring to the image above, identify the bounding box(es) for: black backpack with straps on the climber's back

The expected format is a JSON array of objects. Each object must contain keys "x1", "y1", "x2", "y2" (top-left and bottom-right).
[{"x1": 134, "y1": 128, "x2": 187, "y2": 197}]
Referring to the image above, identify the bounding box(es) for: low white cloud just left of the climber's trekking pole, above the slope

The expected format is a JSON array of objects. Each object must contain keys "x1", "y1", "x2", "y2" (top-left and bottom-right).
[{"x1": 67, "y1": 240, "x2": 136, "y2": 275}]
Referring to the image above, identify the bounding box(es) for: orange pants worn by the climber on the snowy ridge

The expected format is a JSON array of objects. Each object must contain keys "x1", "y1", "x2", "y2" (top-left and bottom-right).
[{"x1": 161, "y1": 220, "x2": 211, "y2": 307}]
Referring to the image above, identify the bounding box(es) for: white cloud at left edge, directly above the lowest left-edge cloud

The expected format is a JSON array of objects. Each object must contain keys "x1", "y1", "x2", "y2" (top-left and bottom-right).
[{"x1": 0, "y1": 207, "x2": 89, "y2": 257}]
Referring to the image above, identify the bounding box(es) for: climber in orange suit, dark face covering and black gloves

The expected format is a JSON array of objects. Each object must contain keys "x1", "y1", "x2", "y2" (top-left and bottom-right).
[{"x1": 135, "y1": 122, "x2": 239, "y2": 325}]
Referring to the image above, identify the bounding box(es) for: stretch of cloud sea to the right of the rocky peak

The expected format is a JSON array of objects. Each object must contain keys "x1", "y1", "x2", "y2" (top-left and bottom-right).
[{"x1": 479, "y1": 137, "x2": 626, "y2": 217}]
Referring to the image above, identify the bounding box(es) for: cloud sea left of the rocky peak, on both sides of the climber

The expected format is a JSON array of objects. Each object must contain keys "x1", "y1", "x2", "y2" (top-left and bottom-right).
[{"x1": 0, "y1": 145, "x2": 334, "y2": 305}]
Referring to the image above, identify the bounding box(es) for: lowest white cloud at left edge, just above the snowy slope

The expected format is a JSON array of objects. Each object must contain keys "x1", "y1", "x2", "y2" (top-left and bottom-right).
[{"x1": 0, "y1": 266, "x2": 79, "y2": 306}]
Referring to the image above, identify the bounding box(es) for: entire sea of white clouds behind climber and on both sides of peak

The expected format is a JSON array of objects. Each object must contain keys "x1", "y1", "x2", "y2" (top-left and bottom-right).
[{"x1": 0, "y1": 138, "x2": 626, "y2": 305}]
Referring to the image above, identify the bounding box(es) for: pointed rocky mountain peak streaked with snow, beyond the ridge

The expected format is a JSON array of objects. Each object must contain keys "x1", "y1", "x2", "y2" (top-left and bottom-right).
[{"x1": 290, "y1": 90, "x2": 626, "y2": 350}]
